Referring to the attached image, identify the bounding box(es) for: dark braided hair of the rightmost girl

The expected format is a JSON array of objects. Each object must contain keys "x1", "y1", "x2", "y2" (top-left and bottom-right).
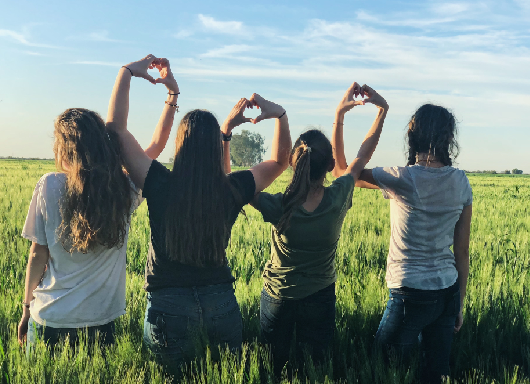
[{"x1": 407, "y1": 104, "x2": 458, "y2": 165}]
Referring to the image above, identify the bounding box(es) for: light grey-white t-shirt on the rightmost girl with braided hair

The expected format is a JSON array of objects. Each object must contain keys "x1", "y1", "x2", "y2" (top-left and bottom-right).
[{"x1": 372, "y1": 165, "x2": 473, "y2": 290}]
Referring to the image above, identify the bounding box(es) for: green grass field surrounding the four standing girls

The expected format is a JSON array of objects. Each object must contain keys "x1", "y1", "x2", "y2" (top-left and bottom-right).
[{"x1": 0, "y1": 160, "x2": 530, "y2": 383}]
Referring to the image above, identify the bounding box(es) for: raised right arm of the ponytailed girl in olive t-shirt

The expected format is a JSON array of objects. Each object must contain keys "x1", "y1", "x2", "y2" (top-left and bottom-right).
[{"x1": 346, "y1": 84, "x2": 388, "y2": 185}]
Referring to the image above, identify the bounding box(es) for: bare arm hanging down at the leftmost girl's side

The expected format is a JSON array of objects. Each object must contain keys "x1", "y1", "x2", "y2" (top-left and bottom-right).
[{"x1": 18, "y1": 242, "x2": 50, "y2": 345}]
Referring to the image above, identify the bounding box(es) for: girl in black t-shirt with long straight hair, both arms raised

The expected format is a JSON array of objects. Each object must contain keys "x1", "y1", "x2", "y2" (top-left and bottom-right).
[{"x1": 104, "y1": 55, "x2": 291, "y2": 373}]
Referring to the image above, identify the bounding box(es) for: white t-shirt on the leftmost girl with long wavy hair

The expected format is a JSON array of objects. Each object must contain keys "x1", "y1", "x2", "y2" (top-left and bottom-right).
[{"x1": 22, "y1": 173, "x2": 143, "y2": 328}]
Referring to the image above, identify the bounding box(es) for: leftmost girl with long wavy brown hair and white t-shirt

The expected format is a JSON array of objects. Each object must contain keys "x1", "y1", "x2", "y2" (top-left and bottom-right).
[{"x1": 18, "y1": 58, "x2": 175, "y2": 350}]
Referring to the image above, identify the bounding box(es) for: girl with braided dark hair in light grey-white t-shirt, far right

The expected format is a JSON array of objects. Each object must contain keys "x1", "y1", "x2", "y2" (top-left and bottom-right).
[{"x1": 333, "y1": 98, "x2": 473, "y2": 383}]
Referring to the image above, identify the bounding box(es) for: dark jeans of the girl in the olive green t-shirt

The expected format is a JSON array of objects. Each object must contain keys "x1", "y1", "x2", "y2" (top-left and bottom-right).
[{"x1": 260, "y1": 283, "x2": 336, "y2": 375}]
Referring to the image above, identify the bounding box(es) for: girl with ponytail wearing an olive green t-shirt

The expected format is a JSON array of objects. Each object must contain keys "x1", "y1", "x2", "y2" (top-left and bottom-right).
[{"x1": 252, "y1": 83, "x2": 388, "y2": 375}]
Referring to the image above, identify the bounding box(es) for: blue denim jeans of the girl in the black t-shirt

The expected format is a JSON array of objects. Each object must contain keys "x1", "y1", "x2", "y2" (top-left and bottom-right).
[{"x1": 144, "y1": 284, "x2": 243, "y2": 376}]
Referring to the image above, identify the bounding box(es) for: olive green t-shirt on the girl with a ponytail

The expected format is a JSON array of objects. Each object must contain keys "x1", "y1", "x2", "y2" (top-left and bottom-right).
[{"x1": 259, "y1": 174, "x2": 355, "y2": 299}]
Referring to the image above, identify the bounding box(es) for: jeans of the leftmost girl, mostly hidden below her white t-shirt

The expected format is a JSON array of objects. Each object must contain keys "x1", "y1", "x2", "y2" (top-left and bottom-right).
[{"x1": 26, "y1": 317, "x2": 115, "y2": 356}]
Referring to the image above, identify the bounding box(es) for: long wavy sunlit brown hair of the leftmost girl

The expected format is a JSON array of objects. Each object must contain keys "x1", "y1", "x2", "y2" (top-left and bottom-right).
[{"x1": 54, "y1": 108, "x2": 132, "y2": 253}]
